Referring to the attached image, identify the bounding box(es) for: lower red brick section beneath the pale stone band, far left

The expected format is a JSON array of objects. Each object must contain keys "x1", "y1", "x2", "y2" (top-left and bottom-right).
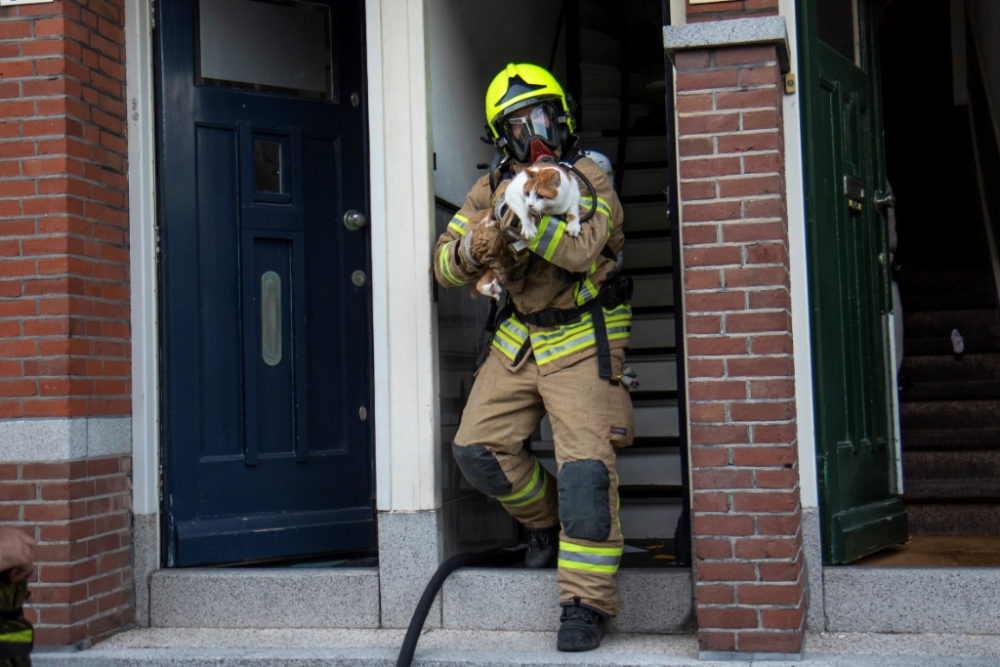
[{"x1": 0, "y1": 457, "x2": 133, "y2": 646}]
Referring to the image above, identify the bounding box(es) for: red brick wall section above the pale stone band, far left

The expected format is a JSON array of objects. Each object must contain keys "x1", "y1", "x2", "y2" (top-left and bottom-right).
[{"x1": 0, "y1": 0, "x2": 131, "y2": 418}]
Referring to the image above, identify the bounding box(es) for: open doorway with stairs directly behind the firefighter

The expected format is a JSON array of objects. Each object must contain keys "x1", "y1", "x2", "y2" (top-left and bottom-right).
[{"x1": 429, "y1": 0, "x2": 690, "y2": 568}]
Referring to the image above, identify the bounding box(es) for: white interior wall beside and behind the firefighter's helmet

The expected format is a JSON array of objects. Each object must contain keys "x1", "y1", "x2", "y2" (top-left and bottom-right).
[{"x1": 427, "y1": 0, "x2": 566, "y2": 205}]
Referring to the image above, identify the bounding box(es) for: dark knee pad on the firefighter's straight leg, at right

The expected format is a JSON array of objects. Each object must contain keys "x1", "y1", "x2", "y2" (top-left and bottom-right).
[{"x1": 559, "y1": 459, "x2": 611, "y2": 542}]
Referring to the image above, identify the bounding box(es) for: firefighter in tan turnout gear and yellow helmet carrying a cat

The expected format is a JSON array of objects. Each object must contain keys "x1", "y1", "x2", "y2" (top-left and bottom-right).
[{"x1": 432, "y1": 64, "x2": 633, "y2": 651}]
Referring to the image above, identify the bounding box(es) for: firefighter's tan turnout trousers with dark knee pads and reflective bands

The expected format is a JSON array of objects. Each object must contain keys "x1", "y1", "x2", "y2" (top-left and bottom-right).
[{"x1": 452, "y1": 349, "x2": 633, "y2": 616}]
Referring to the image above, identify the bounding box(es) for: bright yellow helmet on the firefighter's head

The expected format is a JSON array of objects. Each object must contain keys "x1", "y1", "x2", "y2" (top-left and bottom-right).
[{"x1": 486, "y1": 63, "x2": 576, "y2": 161}]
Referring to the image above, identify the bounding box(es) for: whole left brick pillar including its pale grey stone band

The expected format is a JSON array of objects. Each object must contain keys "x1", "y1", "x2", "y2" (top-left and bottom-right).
[{"x1": 0, "y1": 0, "x2": 132, "y2": 645}]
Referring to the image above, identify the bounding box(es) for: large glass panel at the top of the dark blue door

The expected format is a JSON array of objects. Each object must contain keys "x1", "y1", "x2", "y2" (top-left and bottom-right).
[{"x1": 198, "y1": 0, "x2": 333, "y2": 99}]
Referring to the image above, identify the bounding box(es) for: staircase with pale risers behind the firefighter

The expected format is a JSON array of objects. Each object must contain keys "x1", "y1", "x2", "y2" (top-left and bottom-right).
[{"x1": 533, "y1": 0, "x2": 686, "y2": 565}]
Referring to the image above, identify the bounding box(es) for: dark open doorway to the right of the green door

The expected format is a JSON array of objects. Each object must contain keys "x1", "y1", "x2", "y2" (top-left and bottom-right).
[{"x1": 848, "y1": 0, "x2": 1000, "y2": 567}]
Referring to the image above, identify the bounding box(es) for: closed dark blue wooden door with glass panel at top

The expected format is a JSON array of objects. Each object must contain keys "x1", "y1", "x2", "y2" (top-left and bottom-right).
[{"x1": 157, "y1": 0, "x2": 375, "y2": 566}]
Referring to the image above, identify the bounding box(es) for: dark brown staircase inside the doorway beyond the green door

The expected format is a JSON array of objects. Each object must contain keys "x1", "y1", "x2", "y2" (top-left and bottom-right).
[{"x1": 894, "y1": 108, "x2": 1000, "y2": 535}]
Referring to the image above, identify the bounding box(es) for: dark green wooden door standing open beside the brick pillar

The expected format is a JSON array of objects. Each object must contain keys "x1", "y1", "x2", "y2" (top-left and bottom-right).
[{"x1": 798, "y1": 0, "x2": 907, "y2": 564}]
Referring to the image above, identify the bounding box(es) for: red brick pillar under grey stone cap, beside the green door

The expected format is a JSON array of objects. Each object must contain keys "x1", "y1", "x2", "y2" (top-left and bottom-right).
[{"x1": 675, "y1": 45, "x2": 805, "y2": 653}]
